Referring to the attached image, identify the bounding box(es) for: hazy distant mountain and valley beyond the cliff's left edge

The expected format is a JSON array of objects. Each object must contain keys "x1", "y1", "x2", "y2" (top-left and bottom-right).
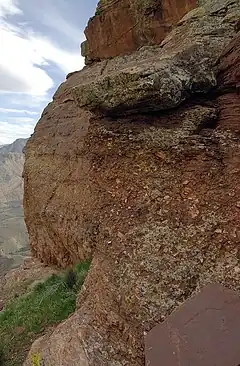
[{"x1": 0, "y1": 139, "x2": 28, "y2": 274}]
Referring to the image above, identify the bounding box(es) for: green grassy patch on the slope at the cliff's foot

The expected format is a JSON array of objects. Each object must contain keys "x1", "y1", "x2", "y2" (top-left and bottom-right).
[{"x1": 0, "y1": 261, "x2": 90, "y2": 366}]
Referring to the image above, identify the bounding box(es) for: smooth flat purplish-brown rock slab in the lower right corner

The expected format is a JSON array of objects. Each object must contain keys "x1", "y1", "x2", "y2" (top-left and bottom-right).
[{"x1": 145, "y1": 284, "x2": 240, "y2": 366}]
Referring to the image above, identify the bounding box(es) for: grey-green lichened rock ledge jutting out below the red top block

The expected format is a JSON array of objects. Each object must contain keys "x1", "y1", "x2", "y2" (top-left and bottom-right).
[{"x1": 76, "y1": 0, "x2": 240, "y2": 115}]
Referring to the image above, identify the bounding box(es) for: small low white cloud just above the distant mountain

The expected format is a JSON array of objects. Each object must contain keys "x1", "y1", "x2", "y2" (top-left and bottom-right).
[{"x1": 0, "y1": 122, "x2": 34, "y2": 145}]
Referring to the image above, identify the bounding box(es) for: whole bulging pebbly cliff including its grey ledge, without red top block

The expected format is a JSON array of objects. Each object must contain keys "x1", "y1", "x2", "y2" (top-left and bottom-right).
[{"x1": 24, "y1": 0, "x2": 240, "y2": 366}]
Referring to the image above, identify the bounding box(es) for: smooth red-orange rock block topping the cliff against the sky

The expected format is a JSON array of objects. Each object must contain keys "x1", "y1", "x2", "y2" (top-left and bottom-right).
[{"x1": 84, "y1": 0, "x2": 197, "y2": 61}]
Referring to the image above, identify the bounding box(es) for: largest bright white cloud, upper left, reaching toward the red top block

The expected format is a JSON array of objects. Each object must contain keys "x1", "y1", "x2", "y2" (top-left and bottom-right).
[{"x1": 0, "y1": 0, "x2": 84, "y2": 96}]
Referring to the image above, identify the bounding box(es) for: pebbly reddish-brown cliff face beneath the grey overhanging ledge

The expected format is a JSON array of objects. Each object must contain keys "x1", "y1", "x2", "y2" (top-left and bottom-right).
[{"x1": 24, "y1": 29, "x2": 240, "y2": 366}]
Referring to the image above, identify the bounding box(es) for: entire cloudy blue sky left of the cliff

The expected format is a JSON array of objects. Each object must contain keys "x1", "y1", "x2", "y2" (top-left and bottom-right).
[{"x1": 0, "y1": 0, "x2": 98, "y2": 145}]
